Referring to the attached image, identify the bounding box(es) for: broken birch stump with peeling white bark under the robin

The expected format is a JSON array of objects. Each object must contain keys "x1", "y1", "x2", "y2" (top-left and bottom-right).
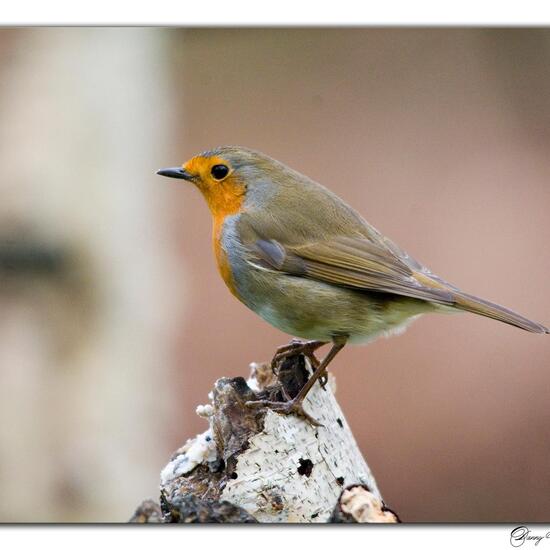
[{"x1": 130, "y1": 355, "x2": 399, "y2": 523}]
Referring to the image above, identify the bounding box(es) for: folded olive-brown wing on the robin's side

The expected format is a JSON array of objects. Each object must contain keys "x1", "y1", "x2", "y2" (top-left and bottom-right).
[{"x1": 248, "y1": 235, "x2": 455, "y2": 305}]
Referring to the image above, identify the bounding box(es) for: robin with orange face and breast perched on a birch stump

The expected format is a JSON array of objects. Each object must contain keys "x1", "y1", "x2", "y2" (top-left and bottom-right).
[{"x1": 157, "y1": 146, "x2": 549, "y2": 424}]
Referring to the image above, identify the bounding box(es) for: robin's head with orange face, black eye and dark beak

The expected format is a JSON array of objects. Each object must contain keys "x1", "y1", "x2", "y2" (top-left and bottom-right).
[{"x1": 157, "y1": 146, "x2": 289, "y2": 216}]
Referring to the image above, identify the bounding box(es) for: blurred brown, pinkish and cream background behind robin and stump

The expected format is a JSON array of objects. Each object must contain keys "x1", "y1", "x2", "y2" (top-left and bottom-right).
[{"x1": 0, "y1": 28, "x2": 550, "y2": 522}]
